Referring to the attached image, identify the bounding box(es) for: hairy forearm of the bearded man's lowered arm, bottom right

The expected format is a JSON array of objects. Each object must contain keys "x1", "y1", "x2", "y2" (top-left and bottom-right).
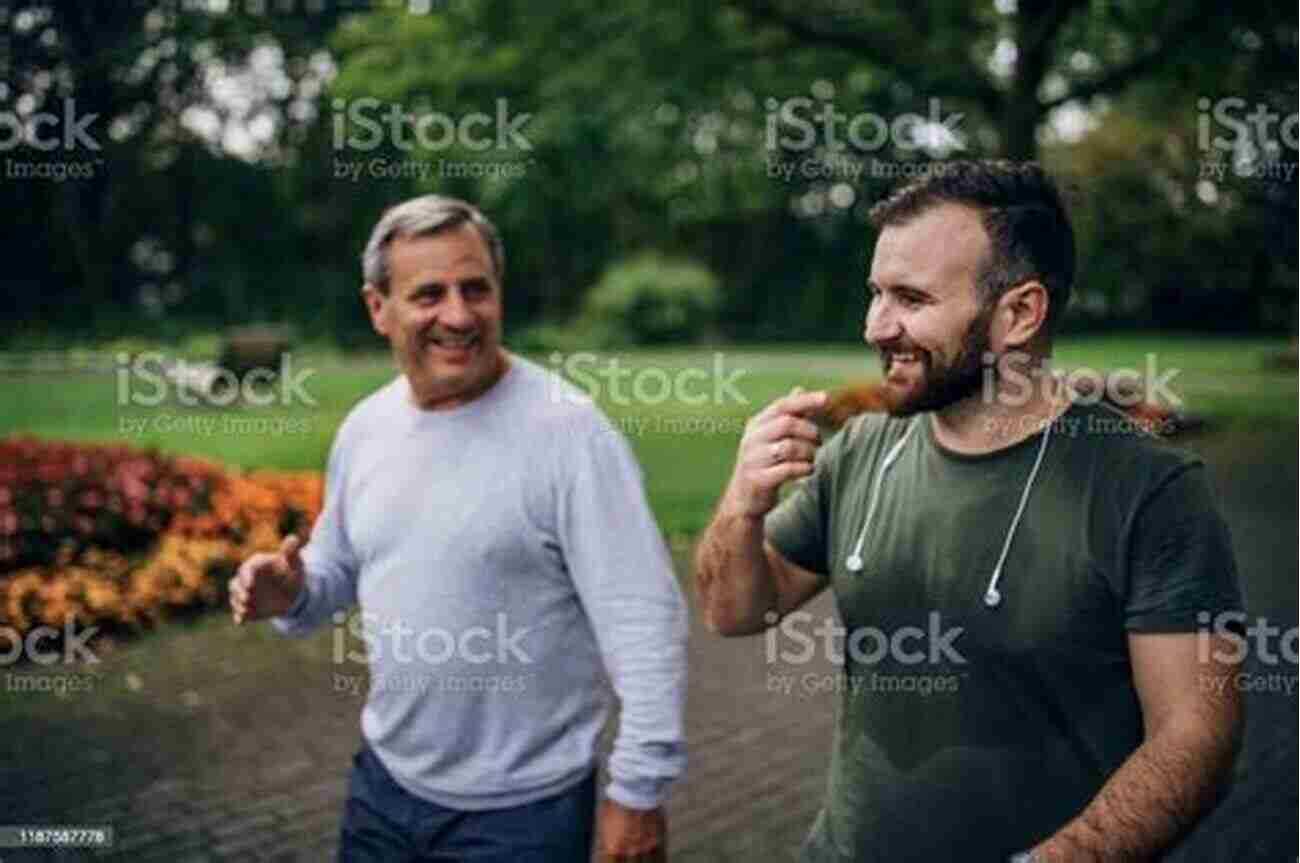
[{"x1": 1035, "y1": 712, "x2": 1239, "y2": 863}]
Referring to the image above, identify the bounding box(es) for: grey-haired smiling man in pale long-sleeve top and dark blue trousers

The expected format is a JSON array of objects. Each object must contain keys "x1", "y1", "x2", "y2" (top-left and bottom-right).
[{"x1": 230, "y1": 196, "x2": 685, "y2": 863}]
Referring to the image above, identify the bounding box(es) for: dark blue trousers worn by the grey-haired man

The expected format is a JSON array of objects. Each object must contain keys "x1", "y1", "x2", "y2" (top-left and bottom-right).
[{"x1": 338, "y1": 746, "x2": 595, "y2": 863}]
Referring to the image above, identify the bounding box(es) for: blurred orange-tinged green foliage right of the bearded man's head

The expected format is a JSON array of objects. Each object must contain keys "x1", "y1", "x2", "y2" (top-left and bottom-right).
[{"x1": 1044, "y1": 65, "x2": 1297, "y2": 333}]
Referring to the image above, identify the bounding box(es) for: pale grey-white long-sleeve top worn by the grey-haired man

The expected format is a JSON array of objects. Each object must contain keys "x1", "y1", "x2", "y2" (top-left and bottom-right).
[{"x1": 274, "y1": 356, "x2": 686, "y2": 810}]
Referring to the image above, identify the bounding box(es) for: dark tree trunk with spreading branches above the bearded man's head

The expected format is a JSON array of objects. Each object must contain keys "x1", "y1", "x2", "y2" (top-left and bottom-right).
[{"x1": 729, "y1": 0, "x2": 1278, "y2": 160}]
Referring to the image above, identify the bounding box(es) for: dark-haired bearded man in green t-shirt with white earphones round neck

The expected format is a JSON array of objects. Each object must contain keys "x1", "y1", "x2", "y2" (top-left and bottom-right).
[{"x1": 697, "y1": 162, "x2": 1240, "y2": 863}]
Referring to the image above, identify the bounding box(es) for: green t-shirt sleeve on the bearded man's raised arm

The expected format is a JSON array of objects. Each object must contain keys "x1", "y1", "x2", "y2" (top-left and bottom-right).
[{"x1": 763, "y1": 426, "x2": 849, "y2": 576}]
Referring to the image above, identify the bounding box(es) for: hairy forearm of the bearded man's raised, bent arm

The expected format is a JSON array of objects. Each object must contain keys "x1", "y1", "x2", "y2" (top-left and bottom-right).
[{"x1": 694, "y1": 500, "x2": 777, "y2": 636}]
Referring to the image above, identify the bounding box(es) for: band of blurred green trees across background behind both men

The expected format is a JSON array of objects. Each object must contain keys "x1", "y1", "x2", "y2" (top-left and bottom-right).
[{"x1": 0, "y1": 0, "x2": 1296, "y2": 347}]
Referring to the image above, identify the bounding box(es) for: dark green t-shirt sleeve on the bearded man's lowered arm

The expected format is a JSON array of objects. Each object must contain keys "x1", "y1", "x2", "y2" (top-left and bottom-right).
[{"x1": 1125, "y1": 463, "x2": 1242, "y2": 632}]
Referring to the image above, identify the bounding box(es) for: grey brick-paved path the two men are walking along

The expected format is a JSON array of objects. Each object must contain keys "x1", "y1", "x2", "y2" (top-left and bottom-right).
[{"x1": 0, "y1": 434, "x2": 1297, "y2": 863}]
